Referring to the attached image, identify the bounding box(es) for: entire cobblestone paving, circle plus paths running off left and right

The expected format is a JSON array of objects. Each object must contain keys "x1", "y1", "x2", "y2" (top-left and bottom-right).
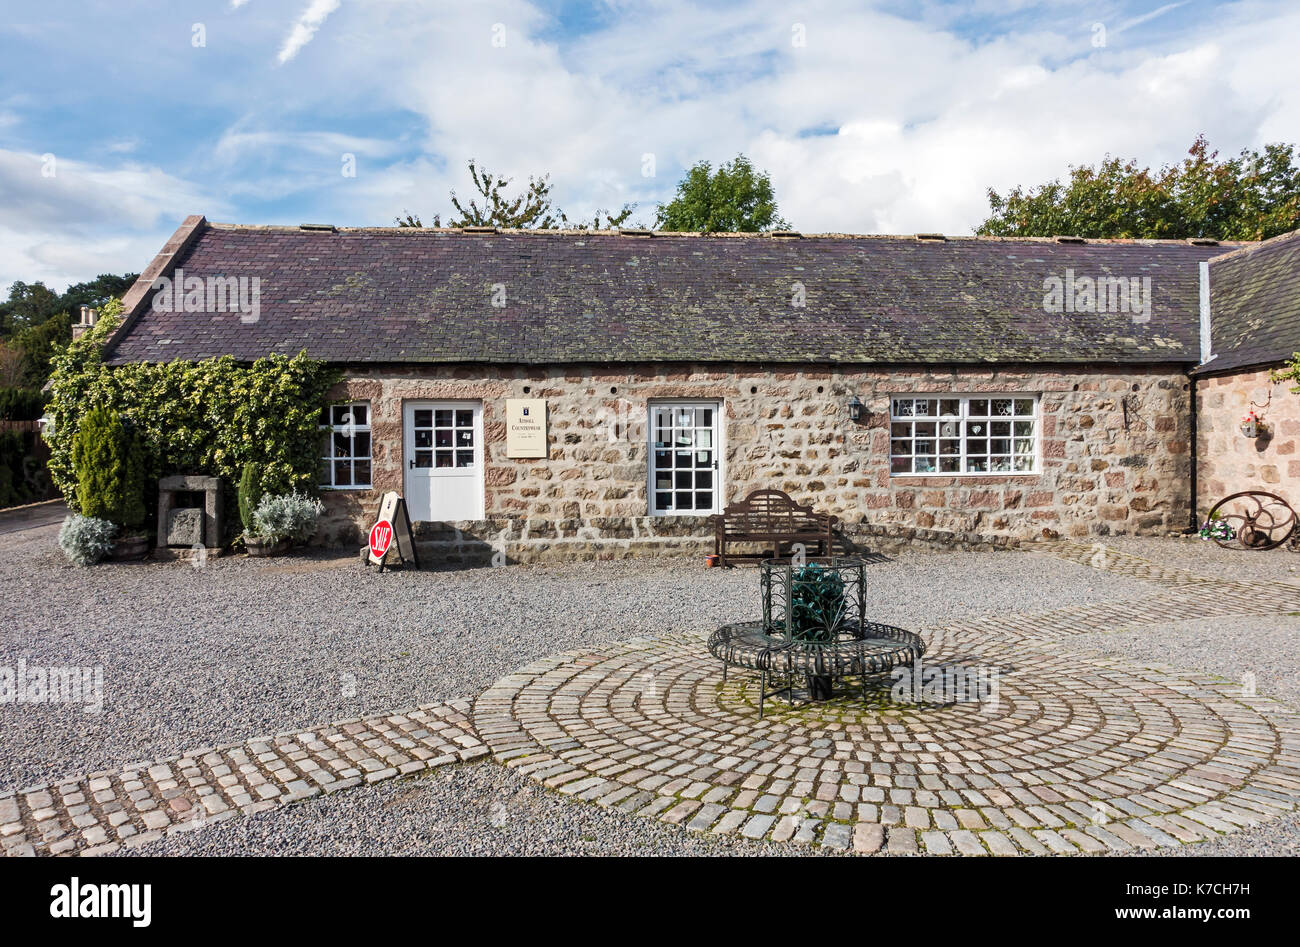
[{"x1": 10, "y1": 542, "x2": 1300, "y2": 855}]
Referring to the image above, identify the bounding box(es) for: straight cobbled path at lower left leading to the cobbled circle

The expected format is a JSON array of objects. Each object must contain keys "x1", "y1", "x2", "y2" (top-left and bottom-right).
[{"x1": 0, "y1": 701, "x2": 488, "y2": 855}]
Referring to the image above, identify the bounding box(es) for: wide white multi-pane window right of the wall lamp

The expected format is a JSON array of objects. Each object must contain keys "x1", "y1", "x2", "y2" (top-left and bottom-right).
[{"x1": 889, "y1": 395, "x2": 1039, "y2": 474}]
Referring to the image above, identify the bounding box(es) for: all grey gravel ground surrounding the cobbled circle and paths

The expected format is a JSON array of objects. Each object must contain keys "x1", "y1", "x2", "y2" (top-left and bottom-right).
[{"x1": 0, "y1": 509, "x2": 1300, "y2": 855}]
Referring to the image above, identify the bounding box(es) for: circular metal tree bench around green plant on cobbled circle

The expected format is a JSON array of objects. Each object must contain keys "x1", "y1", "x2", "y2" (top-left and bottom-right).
[{"x1": 709, "y1": 557, "x2": 926, "y2": 718}]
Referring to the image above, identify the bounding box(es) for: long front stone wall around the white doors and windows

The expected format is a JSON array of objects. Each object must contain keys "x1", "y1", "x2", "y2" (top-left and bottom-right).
[{"x1": 320, "y1": 364, "x2": 1191, "y2": 561}]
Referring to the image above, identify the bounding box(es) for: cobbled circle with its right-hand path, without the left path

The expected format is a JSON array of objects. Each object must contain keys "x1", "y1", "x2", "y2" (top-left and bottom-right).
[{"x1": 473, "y1": 544, "x2": 1300, "y2": 855}]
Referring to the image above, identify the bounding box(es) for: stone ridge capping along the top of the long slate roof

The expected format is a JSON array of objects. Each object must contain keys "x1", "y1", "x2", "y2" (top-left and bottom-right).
[{"x1": 208, "y1": 221, "x2": 1258, "y2": 248}]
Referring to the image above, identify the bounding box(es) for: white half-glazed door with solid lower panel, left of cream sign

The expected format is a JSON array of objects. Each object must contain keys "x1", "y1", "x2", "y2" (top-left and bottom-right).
[{"x1": 403, "y1": 401, "x2": 484, "y2": 522}]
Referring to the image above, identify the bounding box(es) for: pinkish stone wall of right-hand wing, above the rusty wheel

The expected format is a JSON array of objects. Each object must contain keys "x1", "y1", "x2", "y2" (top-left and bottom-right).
[{"x1": 1196, "y1": 369, "x2": 1300, "y2": 516}]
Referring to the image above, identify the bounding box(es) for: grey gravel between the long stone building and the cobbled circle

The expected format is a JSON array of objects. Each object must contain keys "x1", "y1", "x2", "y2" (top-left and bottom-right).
[{"x1": 0, "y1": 515, "x2": 1147, "y2": 790}]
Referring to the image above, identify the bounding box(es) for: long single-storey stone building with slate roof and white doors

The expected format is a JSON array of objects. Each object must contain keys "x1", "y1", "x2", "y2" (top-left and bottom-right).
[{"x1": 96, "y1": 216, "x2": 1294, "y2": 559}]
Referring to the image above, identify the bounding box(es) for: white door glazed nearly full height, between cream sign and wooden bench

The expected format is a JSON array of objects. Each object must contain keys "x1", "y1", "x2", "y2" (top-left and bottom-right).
[{"x1": 647, "y1": 401, "x2": 722, "y2": 515}]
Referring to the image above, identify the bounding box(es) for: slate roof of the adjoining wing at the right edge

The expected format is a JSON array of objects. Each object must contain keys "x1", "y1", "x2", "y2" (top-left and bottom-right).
[{"x1": 1197, "y1": 232, "x2": 1300, "y2": 372}]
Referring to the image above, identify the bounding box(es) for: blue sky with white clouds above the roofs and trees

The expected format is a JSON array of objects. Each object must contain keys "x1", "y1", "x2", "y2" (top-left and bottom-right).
[{"x1": 0, "y1": 0, "x2": 1300, "y2": 287}]
